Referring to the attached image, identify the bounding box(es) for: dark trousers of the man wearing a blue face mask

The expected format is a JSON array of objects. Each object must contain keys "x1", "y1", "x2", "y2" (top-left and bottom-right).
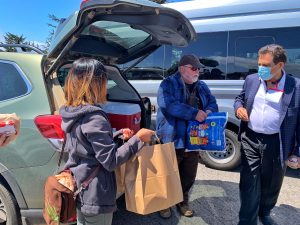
[{"x1": 239, "y1": 128, "x2": 286, "y2": 225}]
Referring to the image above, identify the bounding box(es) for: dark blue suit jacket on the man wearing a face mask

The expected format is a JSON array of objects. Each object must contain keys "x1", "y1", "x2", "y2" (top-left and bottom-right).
[{"x1": 234, "y1": 74, "x2": 300, "y2": 165}]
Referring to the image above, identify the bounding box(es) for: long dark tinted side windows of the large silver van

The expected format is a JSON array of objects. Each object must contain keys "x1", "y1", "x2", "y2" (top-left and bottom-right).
[{"x1": 120, "y1": 27, "x2": 300, "y2": 80}]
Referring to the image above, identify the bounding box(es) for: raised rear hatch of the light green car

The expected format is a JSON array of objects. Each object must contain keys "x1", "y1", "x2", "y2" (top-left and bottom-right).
[{"x1": 43, "y1": 0, "x2": 196, "y2": 75}]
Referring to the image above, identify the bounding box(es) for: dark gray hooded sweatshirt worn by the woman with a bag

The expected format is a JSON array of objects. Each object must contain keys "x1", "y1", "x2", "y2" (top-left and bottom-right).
[{"x1": 59, "y1": 105, "x2": 143, "y2": 215}]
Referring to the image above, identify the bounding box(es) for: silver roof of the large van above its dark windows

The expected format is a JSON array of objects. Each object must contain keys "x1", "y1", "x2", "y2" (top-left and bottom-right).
[{"x1": 165, "y1": 0, "x2": 300, "y2": 33}]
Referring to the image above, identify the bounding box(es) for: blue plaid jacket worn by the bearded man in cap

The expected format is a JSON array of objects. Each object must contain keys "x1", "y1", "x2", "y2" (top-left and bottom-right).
[{"x1": 156, "y1": 72, "x2": 218, "y2": 149}]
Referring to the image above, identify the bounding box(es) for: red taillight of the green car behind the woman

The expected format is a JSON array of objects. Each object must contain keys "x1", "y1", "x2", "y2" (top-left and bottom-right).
[{"x1": 34, "y1": 115, "x2": 65, "y2": 150}]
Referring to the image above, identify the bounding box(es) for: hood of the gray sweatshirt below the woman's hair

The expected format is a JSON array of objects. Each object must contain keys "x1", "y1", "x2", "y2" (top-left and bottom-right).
[{"x1": 59, "y1": 105, "x2": 104, "y2": 133}]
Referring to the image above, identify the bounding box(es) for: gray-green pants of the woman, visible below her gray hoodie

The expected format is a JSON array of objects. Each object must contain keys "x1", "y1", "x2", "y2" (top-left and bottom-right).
[{"x1": 77, "y1": 209, "x2": 113, "y2": 225}]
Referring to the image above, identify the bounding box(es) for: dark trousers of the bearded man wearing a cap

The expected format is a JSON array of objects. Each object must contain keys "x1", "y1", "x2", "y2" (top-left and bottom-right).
[{"x1": 176, "y1": 149, "x2": 199, "y2": 203}]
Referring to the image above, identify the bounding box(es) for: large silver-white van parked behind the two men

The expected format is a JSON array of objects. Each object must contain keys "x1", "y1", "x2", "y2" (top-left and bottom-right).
[{"x1": 118, "y1": 0, "x2": 300, "y2": 170}]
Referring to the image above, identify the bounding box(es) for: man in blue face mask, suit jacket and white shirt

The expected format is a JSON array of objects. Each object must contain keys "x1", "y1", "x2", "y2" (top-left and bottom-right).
[{"x1": 234, "y1": 44, "x2": 300, "y2": 225}]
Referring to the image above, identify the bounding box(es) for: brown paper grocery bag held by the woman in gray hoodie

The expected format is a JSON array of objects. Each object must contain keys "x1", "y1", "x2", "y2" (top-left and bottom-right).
[{"x1": 125, "y1": 143, "x2": 183, "y2": 215}]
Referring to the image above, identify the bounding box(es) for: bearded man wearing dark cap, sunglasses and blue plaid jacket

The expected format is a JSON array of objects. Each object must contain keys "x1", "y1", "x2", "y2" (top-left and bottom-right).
[{"x1": 156, "y1": 55, "x2": 218, "y2": 218}]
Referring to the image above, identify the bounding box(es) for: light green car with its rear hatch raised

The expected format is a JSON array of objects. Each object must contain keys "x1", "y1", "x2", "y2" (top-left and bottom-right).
[{"x1": 0, "y1": 0, "x2": 196, "y2": 225}]
